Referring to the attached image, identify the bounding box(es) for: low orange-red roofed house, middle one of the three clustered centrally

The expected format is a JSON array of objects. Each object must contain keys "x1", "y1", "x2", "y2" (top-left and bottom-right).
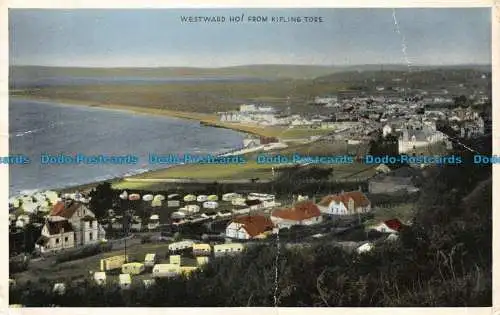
[{"x1": 271, "y1": 201, "x2": 323, "y2": 229}]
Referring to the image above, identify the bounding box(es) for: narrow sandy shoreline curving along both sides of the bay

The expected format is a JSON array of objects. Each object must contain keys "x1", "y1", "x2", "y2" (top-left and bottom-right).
[{"x1": 9, "y1": 95, "x2": 259, "y2": 193}]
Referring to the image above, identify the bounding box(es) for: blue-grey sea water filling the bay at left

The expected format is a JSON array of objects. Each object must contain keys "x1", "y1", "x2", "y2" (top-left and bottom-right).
[{"x1": 9, "y1": 99, "x2": 243, "y2": 195}]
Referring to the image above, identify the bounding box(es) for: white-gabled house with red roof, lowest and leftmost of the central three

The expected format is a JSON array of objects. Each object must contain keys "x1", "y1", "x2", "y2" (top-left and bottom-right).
[{"x1": 226, "y1": 215, "x2": 274, "y2": 240}]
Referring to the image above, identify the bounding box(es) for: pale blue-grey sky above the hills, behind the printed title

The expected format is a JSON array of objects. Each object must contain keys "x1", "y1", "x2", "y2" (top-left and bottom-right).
[{"x1": 9, "y1": 8, "x2": 491, "y2": 67}]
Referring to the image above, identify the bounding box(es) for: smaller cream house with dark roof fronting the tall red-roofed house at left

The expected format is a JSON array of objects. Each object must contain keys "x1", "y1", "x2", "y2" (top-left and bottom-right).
[{"x1": 35, "y1": 219, "x2": 75, "y2": 253}]
